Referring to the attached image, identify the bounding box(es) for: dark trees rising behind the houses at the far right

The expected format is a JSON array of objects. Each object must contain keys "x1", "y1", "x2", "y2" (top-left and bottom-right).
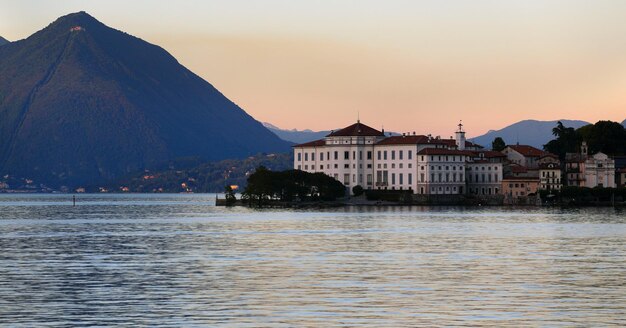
[{"x1": 543, "y1": 121, "x2": 626, "y2": 160}]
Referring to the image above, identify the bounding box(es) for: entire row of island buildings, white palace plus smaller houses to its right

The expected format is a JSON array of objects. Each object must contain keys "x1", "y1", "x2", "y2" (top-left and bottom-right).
[{"x1": 293, "y1": 121, "x2": 616, "y2": 199}]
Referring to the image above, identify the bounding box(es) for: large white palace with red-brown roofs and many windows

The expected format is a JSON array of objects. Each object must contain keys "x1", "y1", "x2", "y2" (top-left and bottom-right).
[{"x1": 293, "y1": 121, "x2": 506, "y2": 195}]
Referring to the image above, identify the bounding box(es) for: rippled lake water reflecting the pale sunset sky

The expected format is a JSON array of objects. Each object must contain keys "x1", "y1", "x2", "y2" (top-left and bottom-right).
[{"x1": 0, "y1": 194, "x2": 626, "y2": 327}]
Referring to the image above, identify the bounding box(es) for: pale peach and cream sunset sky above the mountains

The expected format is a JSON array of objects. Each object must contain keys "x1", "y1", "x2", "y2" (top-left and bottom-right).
[{"x1": 0, "y1": 0, "x2": 626, "y2": 137}]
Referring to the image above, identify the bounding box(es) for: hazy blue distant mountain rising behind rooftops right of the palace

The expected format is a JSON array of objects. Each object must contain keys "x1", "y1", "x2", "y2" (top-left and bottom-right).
[{"x1": 470, "y1": 120, "x2": 590, "y2": 149}]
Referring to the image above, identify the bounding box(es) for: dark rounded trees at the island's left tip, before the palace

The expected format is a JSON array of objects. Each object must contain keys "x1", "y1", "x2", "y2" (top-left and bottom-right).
[{"x1": 242, "y1": 166, "x2": 346, "y2": 206}]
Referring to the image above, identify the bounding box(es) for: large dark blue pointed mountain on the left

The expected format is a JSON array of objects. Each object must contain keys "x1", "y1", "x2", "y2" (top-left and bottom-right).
[{"x1": 0, "y1": 12, "x2": 289, "y2": 186}]
